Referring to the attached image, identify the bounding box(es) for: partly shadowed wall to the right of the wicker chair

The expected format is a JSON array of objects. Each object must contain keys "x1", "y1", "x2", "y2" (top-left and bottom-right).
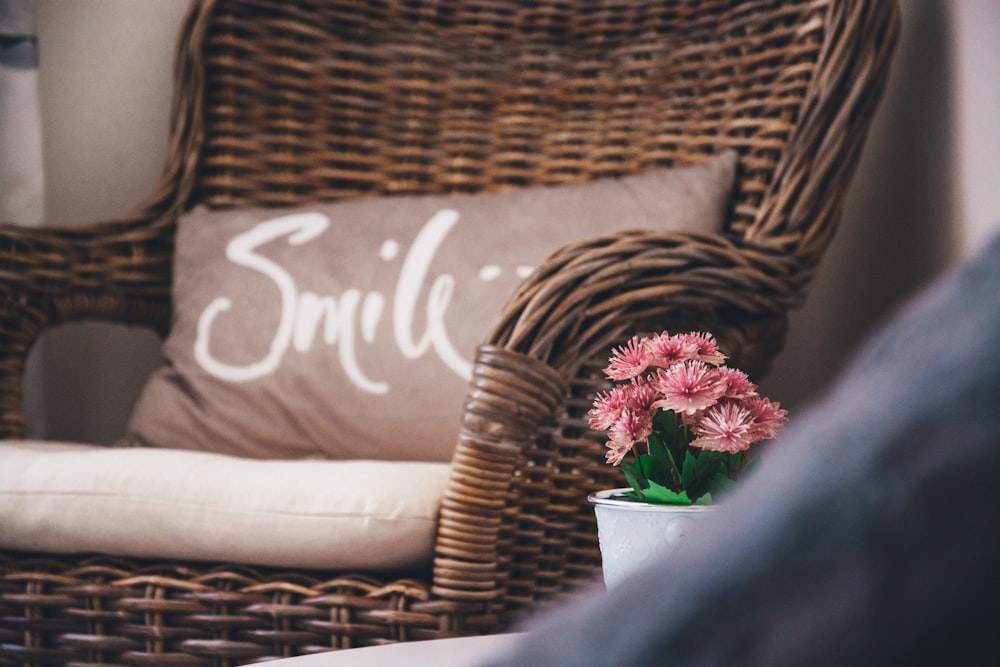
[{"x1": 762, "y1": 0, "x2": 1000, "y2": 406}]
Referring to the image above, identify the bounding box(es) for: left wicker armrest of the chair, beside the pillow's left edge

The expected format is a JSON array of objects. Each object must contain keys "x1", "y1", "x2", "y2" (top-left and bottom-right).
[{"x1": 0, "y1": 209, "x2": 174, "y2": 438}]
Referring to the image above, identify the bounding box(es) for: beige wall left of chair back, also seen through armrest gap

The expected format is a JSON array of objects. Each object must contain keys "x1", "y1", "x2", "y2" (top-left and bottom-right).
[{"x1": 27, "y1": 0, "x2": 187, "y2": 442}]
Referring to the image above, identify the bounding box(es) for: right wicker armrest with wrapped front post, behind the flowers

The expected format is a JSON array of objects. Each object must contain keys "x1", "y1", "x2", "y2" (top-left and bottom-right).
[{"x1": 433, "y1": 231, "x2": 808, "y2": 611}]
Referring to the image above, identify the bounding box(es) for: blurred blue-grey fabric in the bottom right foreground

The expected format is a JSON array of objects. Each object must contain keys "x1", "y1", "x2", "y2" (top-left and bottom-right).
[{"x1": 491, "y1": 238, "x2": 1000, "y2": 667}]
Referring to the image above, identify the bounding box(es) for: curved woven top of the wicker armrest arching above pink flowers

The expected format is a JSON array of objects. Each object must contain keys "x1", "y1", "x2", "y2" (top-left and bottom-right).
[{"x1": 489, "y1": 230, "x2": 808, "y2": 375}]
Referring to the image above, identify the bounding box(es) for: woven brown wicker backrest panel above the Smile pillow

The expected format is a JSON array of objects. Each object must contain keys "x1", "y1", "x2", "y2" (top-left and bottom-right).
[{"x1": 192, "y1": 0, "x2": 828, "y2": 236}]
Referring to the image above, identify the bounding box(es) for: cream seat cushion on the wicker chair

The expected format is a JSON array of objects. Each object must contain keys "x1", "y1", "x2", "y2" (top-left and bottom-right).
[{"x1": 0, "y1": 441, "x2": 449, "y2": 570}]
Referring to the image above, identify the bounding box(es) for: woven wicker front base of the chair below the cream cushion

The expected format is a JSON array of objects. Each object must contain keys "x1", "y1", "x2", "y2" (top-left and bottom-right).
[{"x1": 0, "y1": 556, "x2": 496, "y2": 666}]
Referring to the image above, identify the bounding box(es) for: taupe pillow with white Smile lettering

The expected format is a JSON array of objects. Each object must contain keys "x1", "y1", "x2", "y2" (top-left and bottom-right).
[{"x1": 127, "y1": 152, "x2": 736, "y2": 461}]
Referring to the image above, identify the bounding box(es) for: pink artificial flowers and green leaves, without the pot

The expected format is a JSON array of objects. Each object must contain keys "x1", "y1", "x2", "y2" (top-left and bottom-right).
[{"x1": 588, "y1": 331, "x2": 787, "y2": 505}]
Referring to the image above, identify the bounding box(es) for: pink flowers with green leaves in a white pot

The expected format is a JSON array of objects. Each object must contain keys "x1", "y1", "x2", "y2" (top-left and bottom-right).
[{"x1": 588, "y1": 331, "x2": 787, "y2": 585}]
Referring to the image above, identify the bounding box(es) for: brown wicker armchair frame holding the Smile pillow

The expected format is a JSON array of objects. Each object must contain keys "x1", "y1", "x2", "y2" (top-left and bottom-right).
[{"x1": 0, "y1": 0, "x2": 898, "y2": 665}]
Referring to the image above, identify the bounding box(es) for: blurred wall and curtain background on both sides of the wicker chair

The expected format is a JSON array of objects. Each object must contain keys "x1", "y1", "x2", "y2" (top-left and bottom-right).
[{"x1": 0, "y1": 0, "x2": 1000, "y2": 443}]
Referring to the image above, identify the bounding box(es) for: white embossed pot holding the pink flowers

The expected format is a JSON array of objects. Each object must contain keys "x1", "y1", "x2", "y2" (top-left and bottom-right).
[{"x1": 587, "y1": 487, "x2": 712, "y2": 588}]
